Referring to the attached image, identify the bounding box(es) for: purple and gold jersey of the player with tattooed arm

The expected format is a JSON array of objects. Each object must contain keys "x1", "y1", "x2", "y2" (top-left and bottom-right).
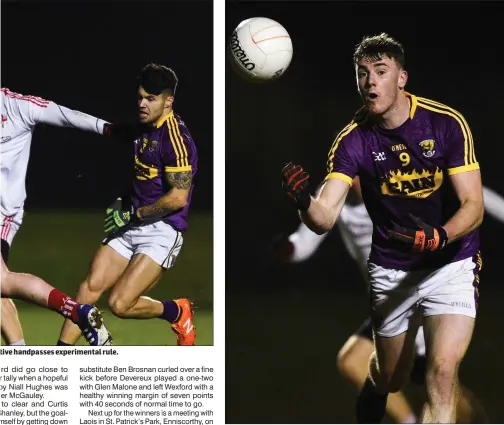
[{"x1": 131, "y1": 111, "x2": 198, "y2": 232}]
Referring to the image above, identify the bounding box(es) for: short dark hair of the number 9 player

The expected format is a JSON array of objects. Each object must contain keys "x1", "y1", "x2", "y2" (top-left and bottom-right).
[{"x1": 353, "y1": 32, "x2": 404, "y2": 68}]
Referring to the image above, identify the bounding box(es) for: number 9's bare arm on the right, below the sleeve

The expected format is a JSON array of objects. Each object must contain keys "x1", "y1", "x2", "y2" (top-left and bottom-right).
[{"x1": 443, "y1": 170, "x2": 485, "y2": 243}]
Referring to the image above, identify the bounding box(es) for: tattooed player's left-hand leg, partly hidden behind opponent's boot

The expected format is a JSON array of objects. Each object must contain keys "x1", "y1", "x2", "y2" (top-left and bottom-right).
[{"x1": 58, "y1": 245, "x2": 132, "y2": 345}]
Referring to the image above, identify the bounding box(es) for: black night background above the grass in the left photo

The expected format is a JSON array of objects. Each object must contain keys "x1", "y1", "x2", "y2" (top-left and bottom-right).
[{"x1": 2, "y1": 0, "x2": 213, "y2": 211}]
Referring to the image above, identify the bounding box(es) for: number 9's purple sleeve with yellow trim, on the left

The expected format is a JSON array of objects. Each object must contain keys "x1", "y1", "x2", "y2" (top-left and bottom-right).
[{"x1": 326, "y1": 123, "x2": 362, "y2": 185}]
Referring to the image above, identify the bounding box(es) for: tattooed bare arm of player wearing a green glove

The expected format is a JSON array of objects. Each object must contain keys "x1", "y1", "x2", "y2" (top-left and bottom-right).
[{"x1": 137, "y1": 171, "x2": 192, "y2": 220}]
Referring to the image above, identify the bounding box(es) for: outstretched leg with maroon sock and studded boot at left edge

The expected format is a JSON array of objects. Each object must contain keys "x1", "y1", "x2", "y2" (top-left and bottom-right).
[{"x1": 0, "y1": 255, "x2": 109, "y2": 345}]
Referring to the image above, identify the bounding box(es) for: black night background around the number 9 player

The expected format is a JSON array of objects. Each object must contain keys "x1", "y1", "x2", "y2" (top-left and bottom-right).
[{"x1": 226, "y1": 2, "x2": 504, "y2": 423}]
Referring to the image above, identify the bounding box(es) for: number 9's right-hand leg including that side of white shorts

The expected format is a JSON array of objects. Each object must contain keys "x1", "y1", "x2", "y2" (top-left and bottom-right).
[{"x1": 419, "y1": 255, "x2": 481, "y2": 423}]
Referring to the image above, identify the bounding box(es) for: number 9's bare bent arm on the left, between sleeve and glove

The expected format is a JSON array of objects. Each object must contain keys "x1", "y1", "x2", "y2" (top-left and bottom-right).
[{"x1": 299, "y1": 178, "x2": 350, "y2": 235}]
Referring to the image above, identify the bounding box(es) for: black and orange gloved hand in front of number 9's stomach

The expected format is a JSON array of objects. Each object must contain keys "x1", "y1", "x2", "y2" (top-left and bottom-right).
[{"x1": 388, "y1": 214, "x2": 448, "y2": 251}]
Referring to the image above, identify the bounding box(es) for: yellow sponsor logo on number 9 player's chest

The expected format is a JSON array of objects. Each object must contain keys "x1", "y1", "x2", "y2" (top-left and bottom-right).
[{"x1": 381, "y1": 167, "x2": 443, "y2": 198}]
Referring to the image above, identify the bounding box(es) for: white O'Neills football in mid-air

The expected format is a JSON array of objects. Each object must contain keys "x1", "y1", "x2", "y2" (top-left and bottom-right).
[{"x1": 228, "y1": 18, "x2": 292, "y2": 82}]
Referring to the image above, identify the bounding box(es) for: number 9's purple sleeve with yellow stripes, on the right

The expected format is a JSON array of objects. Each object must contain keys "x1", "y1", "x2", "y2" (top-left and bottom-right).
[{"x1": 444, "y1": 111, "x2": 479, "y2": 175}]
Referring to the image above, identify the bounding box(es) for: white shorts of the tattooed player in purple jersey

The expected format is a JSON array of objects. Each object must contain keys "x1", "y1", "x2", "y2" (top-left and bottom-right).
[{"x1": 103, "y1": 221, "x2": 184, "y2": 269}]
